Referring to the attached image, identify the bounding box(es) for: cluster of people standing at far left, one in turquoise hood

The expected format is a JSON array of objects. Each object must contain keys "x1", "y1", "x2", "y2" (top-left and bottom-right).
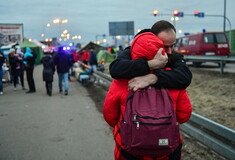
[{"x1": 0, "y1": 46, "x2": 37, "y2": 95}]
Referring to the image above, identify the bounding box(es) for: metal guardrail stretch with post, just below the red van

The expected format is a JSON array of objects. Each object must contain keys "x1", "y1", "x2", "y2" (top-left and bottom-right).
[{"x1": 184, "y1": 55, "x2": 235, "y2": 74}]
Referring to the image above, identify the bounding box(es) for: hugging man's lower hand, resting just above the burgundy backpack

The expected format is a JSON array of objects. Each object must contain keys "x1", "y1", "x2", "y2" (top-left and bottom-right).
[{"x1": 128, "y1": 74, "x2": 157, "y2": 91}]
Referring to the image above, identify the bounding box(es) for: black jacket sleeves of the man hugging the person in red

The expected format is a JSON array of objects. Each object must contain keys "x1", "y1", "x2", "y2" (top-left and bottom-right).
[{"x1": 109, "y1": 47, "x2": 192, "y2": 89}]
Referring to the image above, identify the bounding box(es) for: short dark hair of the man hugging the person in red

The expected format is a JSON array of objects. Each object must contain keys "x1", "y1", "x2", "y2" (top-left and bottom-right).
[{"x1": 151, "y1": 20, "x2": 176, "y2": 35}]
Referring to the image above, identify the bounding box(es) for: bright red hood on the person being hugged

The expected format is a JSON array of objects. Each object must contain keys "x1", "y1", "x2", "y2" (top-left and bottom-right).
[{"x1": 131, "y1": 32, "x2": 164, "y2": 60}]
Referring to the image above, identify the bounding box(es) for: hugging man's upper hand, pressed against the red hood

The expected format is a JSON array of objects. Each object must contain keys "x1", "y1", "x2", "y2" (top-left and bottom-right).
[{"x1": 148, "y1": 48, "x2": 168, "y2": 70}]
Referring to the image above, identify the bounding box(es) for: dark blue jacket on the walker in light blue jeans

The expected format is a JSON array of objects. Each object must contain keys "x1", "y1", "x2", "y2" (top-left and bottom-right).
[{"x1": 54, "y1": 50, "x2": 72, "y2": 73}]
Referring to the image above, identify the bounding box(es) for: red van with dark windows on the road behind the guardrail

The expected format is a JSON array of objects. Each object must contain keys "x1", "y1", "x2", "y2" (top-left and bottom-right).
[{"x1": 175, "y1": 32, "x2": 230, "y2": 56}]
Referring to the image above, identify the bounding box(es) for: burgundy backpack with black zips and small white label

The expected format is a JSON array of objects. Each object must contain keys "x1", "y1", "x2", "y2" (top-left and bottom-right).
[{"x1": 120, "y1": 87, "x2": 180, "y2": 157}]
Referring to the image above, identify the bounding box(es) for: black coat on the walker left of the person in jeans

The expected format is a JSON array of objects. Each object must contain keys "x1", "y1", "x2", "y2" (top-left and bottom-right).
[{"x1": 41, "y1": 54, "x2": 55, "y2": 82}]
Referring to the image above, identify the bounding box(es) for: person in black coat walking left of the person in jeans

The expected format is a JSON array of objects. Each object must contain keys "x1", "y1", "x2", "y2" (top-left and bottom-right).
[{"x1": 40, "y1": 53, "x2": 55, "y2": 96}]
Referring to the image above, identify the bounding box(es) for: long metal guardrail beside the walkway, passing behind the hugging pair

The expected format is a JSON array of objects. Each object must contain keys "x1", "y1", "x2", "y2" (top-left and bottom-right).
[{"x1": 91, "y1": 71, "x2": 235, "y2": 160}]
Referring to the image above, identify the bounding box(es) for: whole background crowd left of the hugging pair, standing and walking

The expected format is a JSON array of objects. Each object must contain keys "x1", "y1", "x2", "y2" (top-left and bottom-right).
[{"x1": 0, "y1": 46, "x2": 100, "y2": 96}]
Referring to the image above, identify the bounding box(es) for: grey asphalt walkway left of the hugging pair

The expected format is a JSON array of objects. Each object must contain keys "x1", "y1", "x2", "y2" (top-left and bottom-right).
[{"x1": 0, "y1": 66, "x2": 114, "y2": 160}]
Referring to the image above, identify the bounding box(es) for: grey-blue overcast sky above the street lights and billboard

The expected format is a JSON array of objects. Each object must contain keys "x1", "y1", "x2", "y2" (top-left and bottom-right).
[{"x1": 0, "y1": 0, "x2": 235, "y2": 43}]
